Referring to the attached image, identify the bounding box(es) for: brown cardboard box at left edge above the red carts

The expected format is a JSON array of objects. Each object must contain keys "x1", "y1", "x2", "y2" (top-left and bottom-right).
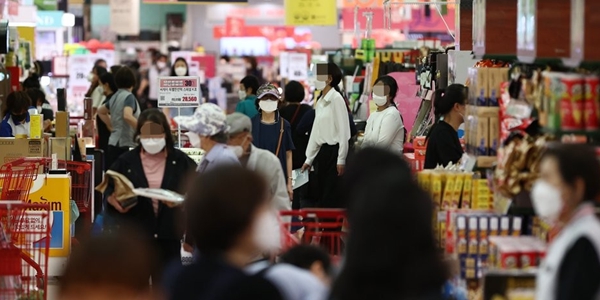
[{"x1": 0, "y1": 138, "x2": 47, "y2": 164}]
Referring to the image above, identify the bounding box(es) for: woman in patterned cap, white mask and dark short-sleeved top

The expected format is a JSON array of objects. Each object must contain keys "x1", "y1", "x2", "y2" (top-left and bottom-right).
[{"x1": 252, "y1": 83, "x2": 294, "y2": 199}]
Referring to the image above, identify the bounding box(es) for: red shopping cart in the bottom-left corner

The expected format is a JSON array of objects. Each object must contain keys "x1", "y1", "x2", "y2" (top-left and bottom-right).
[{"x1": 0, "y1": 201, "x2": 52, "y2": 300}]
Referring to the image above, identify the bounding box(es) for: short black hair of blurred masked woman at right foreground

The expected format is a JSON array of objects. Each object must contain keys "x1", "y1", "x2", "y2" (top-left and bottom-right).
[{"x1": 542, "y1": 142, "x2": 600, "y2": 202}]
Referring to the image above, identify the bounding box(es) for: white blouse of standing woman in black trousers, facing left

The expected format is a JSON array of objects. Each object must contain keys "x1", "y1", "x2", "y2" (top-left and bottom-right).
[{"x1": 305, "y1": 89, "x2": 350, "y2": 165}]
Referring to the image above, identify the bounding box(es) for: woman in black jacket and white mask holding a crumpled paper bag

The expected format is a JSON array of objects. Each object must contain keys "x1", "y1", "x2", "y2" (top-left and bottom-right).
[{"x1": 105, "y1": 109, "x2": 196, "y2": 285}]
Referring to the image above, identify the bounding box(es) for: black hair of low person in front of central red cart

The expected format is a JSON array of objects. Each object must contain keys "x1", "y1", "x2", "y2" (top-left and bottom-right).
[{"x1": 280, "y1": 245, "x2": 331, "y2": 274}]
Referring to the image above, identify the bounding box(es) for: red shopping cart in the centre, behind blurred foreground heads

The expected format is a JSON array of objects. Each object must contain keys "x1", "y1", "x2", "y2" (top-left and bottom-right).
[{"x1": 280, "y1": 209, "x2": 346, "y2": 258}]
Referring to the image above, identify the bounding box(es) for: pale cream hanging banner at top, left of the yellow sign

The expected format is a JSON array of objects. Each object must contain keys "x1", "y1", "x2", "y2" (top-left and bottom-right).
[{"x1": 109, "y1": 0, "x2": 140, "y2": 35}]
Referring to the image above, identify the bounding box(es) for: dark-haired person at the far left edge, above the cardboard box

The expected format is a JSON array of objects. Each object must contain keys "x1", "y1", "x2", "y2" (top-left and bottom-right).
[{"x1": 0, "y1": 91, "x2": 31, "y2": 137}]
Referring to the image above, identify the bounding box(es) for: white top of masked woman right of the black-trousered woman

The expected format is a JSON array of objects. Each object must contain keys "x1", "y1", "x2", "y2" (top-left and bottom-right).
[{"x1": 362, "y1": 106, "x2": 404, "y2": 153}]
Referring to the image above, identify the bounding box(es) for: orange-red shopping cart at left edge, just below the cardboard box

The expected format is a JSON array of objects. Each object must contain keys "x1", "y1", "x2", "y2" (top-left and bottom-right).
[{"x1": 0, "y1": 159, "x2": 40, "y2": 201}]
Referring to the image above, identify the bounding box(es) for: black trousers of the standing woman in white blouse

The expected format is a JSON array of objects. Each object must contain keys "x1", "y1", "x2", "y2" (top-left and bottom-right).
[{"x1": 311, "y1": 144, "x2": 343, "y2": 208}]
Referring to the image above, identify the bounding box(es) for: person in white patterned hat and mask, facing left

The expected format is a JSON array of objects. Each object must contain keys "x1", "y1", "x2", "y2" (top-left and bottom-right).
[{"x1": 175, "y1": 103, "x2": 240, "y2": 173}]
